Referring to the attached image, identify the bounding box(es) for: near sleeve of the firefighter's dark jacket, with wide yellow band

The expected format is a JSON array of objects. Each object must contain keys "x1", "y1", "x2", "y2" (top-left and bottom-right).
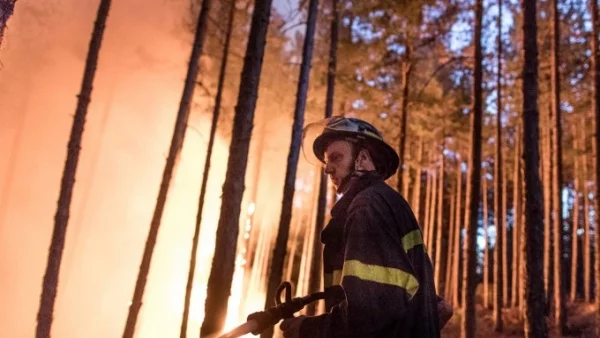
[{"x1": 301, "y1": 199, "x2": 422, "y2": 338}]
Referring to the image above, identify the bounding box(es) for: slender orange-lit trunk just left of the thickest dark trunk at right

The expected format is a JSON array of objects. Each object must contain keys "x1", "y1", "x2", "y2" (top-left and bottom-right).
[{"x1": 512, "y1": 125, "x2": 523, "y2": 306}]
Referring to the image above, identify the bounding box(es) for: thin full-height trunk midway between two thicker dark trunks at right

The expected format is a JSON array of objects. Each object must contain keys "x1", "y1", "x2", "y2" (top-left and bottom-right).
[{"x1": 494, "y1": 0, "x2": 508, "y2": 326}]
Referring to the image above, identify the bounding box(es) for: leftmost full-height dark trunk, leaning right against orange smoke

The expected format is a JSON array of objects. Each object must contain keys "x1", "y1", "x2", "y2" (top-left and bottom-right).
[{"x1": 35, "y1": 0, "x2": 111, "y2": 338}]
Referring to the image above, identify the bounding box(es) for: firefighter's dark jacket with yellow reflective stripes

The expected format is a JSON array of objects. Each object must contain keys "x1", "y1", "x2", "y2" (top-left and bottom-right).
[{"x1": 300, "y1": 172, "x2": 440, "y2": 338}]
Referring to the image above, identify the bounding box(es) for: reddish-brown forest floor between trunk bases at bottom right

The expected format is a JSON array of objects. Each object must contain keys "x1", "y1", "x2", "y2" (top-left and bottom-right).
[{"x1": 442, "y1": 302, "x2": 596, "y2": 338}]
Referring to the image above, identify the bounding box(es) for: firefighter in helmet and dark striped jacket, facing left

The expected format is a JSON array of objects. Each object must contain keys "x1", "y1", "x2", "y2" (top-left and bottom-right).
[{"x1": 280, "y1": 116, "x2": 452, "y2": 338}]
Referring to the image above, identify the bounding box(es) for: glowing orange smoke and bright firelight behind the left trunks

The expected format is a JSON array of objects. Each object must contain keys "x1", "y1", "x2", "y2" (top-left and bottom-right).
[{"x1": 0, "y1": 0, "x2": 236, "y2": 338}]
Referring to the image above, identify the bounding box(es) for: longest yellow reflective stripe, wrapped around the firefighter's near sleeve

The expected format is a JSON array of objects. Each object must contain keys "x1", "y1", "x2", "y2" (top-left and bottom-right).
[{"x1": 342, "y1": 260, "x2": 419, "y2": 298}]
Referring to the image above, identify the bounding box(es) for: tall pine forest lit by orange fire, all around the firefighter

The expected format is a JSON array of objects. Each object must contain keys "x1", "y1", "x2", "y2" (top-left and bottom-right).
[{"x1": 0, "y1": 0, "x2": 600, "y2": 338}]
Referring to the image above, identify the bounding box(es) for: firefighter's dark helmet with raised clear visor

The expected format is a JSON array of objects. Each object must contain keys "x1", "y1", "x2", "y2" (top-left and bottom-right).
[{"x1": 302, "y1": 116, "x2": 399, "y2": 179}]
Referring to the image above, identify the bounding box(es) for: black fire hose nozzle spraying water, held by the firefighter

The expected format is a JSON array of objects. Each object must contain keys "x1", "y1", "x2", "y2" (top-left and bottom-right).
[{"x1": 213, "y1": 282, "x2": 332, "y2": 338}]
